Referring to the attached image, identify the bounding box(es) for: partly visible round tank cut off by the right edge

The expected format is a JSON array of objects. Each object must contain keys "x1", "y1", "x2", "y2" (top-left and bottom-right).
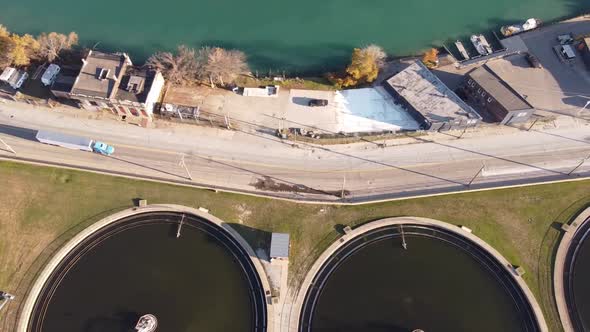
[{"x1": 555, "y1": 208, "x2": 590, "y2": 332}]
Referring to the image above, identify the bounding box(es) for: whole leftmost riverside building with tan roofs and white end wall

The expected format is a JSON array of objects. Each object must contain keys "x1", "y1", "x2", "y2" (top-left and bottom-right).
[{"x1": 51, "y1": 50, "x2": 164, "y2": 126}]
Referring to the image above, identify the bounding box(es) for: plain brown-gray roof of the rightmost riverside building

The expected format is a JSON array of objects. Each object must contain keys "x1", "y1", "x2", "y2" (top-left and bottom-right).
[{"x1": 467, "y1": 65, "x2": 533, "y2": 111}]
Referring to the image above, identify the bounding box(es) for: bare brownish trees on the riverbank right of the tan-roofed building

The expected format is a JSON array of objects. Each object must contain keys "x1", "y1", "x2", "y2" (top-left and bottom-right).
[{"x1": 146, "y1": 45, "x2": 250, "y2": 86}]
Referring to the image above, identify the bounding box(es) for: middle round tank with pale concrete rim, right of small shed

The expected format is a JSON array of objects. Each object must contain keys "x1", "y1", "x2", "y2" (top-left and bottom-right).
[{"x1": 295, "y1": 218, "x2": 547, "y2": 332}]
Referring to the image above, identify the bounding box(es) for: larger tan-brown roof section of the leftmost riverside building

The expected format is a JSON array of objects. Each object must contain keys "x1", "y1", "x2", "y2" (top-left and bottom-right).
[{"x1": 71, "y1": 51, "x2": 131, "y2": 99}]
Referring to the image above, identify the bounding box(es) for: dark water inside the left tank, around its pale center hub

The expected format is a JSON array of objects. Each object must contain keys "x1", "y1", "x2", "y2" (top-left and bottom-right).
[{"x1": 43, "y1": 224, "x2": 253, "y2": 332}]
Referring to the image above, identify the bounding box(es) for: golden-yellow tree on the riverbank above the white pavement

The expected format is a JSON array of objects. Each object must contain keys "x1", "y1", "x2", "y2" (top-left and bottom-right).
[{"x1": 328, "y1": 45, "x2": 387, "y2": 89}]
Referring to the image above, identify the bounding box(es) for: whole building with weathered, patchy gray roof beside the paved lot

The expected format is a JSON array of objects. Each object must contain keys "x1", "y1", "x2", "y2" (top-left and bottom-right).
[{"x1": 383, "y1": 61, "x2": 482, "y2": 131}]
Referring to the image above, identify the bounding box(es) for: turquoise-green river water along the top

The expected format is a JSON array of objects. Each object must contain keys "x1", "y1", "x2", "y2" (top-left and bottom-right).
[{"x1": 0, "y1": 0, "x2": 590, "y2": 71}]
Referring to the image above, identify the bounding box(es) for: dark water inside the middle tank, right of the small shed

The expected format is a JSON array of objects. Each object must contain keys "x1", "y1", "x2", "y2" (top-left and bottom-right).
[{"x1": 311, "y1": 236, "x2": 523, "y2": 332}]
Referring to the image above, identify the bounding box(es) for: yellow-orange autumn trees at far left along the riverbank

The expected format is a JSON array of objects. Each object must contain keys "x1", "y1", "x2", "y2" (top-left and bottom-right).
[{"x1": 0, "y1": 25, "x2": 78, "y2": 68}]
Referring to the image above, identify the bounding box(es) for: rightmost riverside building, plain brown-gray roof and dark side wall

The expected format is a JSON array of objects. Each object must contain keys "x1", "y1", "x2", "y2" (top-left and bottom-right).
[{"x1": 461, "y1": 65, "x2": 535, "y2": 124}]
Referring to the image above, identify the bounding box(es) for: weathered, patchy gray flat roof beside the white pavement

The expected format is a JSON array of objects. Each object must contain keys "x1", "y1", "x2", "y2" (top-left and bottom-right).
[{"x1": 385, "y1": 61, "x2": 481, "y2": 123}]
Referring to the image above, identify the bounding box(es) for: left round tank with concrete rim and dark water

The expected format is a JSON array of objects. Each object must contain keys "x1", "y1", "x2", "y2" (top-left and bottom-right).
[{"x1": 21, "y1": 209, "x2": 267, "y2": 332}]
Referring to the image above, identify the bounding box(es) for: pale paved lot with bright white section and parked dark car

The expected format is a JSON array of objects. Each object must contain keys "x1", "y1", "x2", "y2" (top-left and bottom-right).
[{"x1": 164, "y1": 87, "x2": 418, "y2": 133}]
